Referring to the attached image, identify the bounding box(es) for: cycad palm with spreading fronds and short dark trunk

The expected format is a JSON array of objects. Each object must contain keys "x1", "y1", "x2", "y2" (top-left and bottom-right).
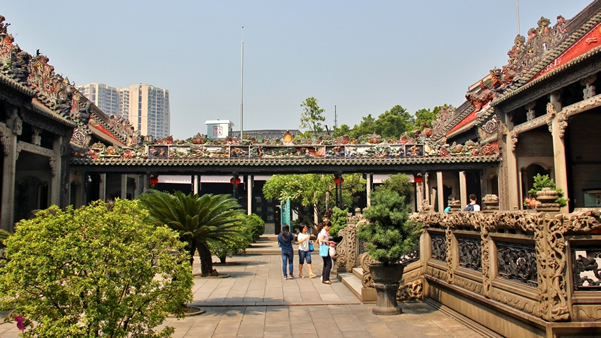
[{"x1": 140, "y1": 190, "x2": 243, "y2": 276}]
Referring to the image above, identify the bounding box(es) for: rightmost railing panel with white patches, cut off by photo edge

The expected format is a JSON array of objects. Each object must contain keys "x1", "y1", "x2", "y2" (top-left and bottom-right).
[{"x1": 572, "y1": 246, "x2": 601, "y2": 291}]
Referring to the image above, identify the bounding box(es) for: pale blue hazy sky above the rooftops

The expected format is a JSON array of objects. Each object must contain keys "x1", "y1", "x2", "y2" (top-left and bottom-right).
[{"x1": 0, "y1": 0, "x2": 591, "y2": 139}]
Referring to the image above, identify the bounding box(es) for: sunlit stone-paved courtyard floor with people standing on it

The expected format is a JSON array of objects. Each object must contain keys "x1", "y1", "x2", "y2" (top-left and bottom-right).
[{"x1": 0, "y1": 255, "x2": 480, "y2": 338}]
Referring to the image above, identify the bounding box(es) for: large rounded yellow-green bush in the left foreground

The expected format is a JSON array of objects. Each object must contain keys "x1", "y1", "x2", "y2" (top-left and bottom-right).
[{"x1": 0, "y1": 199, "x2": 193, "y2": 337}]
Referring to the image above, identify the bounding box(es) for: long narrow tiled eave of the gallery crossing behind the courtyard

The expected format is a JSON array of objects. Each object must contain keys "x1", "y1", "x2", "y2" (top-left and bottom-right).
[{"x1": 71, "y1": 155, "x2": 500, "y2": 167}]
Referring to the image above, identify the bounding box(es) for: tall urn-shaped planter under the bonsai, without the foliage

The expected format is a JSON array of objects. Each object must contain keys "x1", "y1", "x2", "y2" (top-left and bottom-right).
[{"x1": 368, "y1": 263, "x2": 405, "y2": 315}]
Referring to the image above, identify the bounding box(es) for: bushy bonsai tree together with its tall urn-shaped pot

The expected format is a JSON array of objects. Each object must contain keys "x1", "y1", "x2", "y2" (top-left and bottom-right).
[{"x1": 357, "y1": 189, "x2": 422, "y2": 315}]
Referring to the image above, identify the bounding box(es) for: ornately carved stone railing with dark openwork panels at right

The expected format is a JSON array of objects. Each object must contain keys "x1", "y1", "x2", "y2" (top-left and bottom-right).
[{"x1": 414, "y1": 210, "x2": 601, "y2": 322}]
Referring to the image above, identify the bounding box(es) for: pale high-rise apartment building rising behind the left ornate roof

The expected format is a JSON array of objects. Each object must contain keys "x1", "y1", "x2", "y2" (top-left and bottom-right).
[{"x1": 77, "y1": 83, "x2": 171, "y2": 138}]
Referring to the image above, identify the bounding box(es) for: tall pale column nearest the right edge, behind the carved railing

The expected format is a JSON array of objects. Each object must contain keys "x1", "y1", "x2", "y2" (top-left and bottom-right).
[{"x1": 547, "y1": 93, "x2": 570, "y2": 213}]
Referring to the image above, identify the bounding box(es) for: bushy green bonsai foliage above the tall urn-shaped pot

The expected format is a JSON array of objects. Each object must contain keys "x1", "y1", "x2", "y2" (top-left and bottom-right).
[{"x1": 357, "y1": 189, "x2": 422, "y2": 265}]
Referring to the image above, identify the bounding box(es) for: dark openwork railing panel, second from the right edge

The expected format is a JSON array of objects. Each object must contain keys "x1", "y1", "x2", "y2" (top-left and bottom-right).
[{"x1": 496, "y1": 241, "x2": 538, "y2": 287}]
